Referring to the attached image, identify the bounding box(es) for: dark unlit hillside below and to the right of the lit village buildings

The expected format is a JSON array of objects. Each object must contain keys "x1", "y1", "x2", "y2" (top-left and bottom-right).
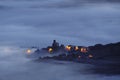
[{"x1": 37, "y1": 42, "x2": 120, "y2": 75}]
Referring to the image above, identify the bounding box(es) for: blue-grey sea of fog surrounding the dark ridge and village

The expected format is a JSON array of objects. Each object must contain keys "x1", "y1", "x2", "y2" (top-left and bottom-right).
[{"x1": 0, "y1": 0, "x2": 120, "y2": 80}]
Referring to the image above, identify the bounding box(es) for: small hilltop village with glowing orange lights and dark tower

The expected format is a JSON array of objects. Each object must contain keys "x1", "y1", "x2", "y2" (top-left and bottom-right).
[{"x1": 27, "y1": 40, "x2": 93, "y2": 61}]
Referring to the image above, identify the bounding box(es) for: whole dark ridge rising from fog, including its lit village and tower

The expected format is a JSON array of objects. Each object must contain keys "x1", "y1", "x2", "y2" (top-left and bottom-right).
[{"x1": 32, "y1": 40, "x2": 120, "y2": 75}]
